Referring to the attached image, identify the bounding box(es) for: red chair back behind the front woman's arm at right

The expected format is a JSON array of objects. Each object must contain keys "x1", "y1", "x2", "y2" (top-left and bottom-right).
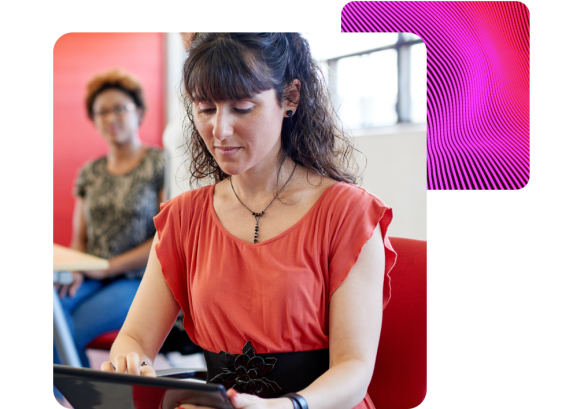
[{"x1": 368, "y1": 237, "x2": 428, "y2": 409}]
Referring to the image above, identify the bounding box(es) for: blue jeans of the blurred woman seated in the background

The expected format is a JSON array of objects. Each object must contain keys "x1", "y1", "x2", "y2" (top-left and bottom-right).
[{"x1": 53, "y1": 278, "x2": 141, "y2": 397}]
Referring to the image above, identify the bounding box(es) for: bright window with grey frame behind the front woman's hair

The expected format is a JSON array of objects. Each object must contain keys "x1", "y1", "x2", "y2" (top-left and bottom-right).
[{"x1": 302, "y1": 32, "x2": 426, "y2": 129}]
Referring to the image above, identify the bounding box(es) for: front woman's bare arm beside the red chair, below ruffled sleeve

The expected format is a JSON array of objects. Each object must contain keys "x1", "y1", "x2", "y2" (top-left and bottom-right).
[{"x1": 298, "y1": 225, "x2": 385, "y2": 409}]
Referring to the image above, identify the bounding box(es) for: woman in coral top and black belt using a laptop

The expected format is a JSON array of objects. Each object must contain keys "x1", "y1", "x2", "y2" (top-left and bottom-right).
[{"x1": 102, "y1": 32, "x2": 396, "y2": 409}]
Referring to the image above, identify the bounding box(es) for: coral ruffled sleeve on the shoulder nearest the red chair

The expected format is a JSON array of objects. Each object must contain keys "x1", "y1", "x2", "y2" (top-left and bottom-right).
[{"x1": 328, "y1": 186, "x2": 397, "y2": 308}]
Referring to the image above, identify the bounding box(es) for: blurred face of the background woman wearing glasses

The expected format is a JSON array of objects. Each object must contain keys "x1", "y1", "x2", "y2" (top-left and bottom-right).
[{"x1": 93, "y1": 89, "x2": 142, "y2": 145}]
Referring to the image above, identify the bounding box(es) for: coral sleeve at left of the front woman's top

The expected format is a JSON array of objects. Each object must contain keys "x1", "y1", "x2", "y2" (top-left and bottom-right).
[{"x1": 154, "y1": 196, "x2": 192, "y2": 334}]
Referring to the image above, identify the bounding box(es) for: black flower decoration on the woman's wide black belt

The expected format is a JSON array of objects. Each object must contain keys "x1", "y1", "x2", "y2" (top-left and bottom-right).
[{"x1": 209, "y1": 341, "x2": 282, "y2": 398}]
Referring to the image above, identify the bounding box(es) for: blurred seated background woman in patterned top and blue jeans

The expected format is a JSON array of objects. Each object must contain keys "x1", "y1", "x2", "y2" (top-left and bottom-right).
[{"x1": 53, "y1": 70, "x2": 164, "y2": 382}]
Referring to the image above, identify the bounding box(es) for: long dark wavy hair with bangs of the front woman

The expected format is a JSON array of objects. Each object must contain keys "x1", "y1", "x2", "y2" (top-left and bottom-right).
[{"x1": 182, "y1": 32, "x2": 361, "y2": 186}]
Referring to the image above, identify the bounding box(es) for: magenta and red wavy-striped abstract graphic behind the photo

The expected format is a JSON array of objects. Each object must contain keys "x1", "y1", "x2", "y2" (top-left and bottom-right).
[{"x1": 341, "y1": 1, "x2": 531, "y2": 190}]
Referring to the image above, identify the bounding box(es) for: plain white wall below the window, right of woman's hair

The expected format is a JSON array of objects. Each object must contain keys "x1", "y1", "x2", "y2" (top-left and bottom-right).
[{"x1": 352, "y1": 125, "x2": 428, "y2": 240}]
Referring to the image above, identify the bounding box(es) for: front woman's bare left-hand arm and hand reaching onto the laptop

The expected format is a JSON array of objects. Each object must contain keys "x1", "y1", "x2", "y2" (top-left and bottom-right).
[{"x1": 101, "y1": 231, "x2": 180, "y2": 376}]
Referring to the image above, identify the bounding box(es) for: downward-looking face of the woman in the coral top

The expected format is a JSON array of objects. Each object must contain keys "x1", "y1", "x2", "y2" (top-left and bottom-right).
[{"x1": 193, "y1": 89, "x2": 287, "y2": 175}]
